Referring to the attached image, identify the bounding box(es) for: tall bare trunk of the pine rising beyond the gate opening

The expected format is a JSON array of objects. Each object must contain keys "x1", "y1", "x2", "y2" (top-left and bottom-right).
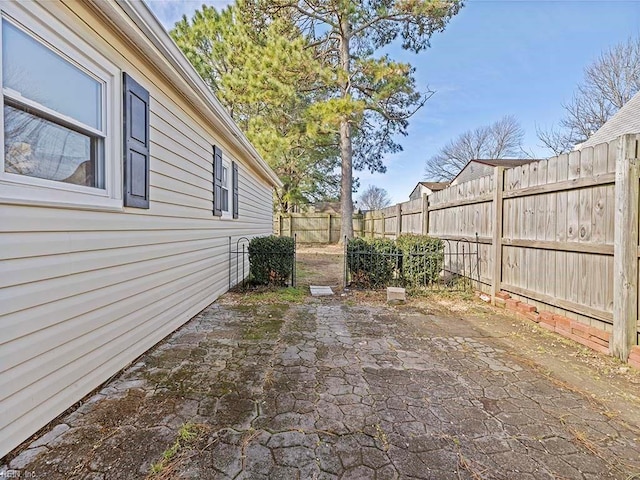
[{"x1": 340, "y1": 12, "x2": 353, "y2": 242}]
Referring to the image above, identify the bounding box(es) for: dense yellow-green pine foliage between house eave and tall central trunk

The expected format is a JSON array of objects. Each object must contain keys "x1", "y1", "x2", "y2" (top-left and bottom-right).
[{"x1": 171, "y1": 2, "x2": 340, "y2": 212}]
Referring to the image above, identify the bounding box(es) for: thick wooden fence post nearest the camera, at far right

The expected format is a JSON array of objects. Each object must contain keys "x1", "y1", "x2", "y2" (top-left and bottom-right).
[{"x1": 610, "y1": 135, "x2": 640, "y2": 361}]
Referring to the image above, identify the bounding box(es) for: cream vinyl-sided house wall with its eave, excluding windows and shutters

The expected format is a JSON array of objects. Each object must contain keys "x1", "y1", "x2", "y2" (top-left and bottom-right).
[{"x1": 0, "y1": 1, "x2": 273, "y2": 457}]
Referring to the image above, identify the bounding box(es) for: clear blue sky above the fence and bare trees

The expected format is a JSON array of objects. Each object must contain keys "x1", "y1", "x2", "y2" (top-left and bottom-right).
[{"x1": 147, "y1": 0, "x2": 640, "y2": 203}]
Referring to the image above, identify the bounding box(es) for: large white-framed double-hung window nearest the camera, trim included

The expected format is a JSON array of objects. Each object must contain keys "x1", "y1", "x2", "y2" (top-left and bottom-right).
[{"x1": 0, "y1": 2, "x2": 122, "y2": 208}]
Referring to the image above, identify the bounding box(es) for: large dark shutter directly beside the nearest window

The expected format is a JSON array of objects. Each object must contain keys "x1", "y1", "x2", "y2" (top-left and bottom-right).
[{"x1": 122, "y1": 73, "x2": 150, "y2": 208}]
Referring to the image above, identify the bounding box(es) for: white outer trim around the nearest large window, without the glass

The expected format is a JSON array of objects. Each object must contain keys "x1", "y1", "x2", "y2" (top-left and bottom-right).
[{"x1": 0, "y1": 2, "x2": 123, "y2": 211}]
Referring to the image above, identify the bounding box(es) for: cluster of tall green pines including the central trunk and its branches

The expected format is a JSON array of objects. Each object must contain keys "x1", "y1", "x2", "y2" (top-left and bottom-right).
[{"x1": 171, "y1": 0, "x2": 462, "y2": 227}]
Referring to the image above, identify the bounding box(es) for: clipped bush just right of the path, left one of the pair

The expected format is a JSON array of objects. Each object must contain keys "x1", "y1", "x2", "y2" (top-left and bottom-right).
[{"x1": 347, "y1": 238, "x2": 401, "y2": 288}]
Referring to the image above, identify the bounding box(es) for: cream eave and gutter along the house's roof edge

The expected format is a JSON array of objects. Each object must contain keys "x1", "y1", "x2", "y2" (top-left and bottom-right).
[{"x1": 90, "y1": 0, "x2": 282, "y2": 187}]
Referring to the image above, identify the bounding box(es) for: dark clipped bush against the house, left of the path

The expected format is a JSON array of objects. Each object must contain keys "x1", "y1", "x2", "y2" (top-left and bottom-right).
[{"x1": 249, "y1": 235, "x2": 295, "y2": 286}]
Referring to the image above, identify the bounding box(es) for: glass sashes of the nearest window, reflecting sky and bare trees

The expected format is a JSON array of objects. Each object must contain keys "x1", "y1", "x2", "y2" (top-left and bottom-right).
[{"x1": 2, "y1": 19, "x2": 105, "y2": 188}]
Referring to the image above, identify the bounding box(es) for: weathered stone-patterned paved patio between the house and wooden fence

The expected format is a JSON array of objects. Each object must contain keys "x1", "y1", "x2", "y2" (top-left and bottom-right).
[{"x1": 5, "y1": 299, "x2": 640, "y2": 479}]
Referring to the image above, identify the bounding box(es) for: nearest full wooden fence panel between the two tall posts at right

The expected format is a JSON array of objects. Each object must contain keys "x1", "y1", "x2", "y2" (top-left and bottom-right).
[{"x1": 501, "y1": 142, "x2": 616, "y2": 328}]
